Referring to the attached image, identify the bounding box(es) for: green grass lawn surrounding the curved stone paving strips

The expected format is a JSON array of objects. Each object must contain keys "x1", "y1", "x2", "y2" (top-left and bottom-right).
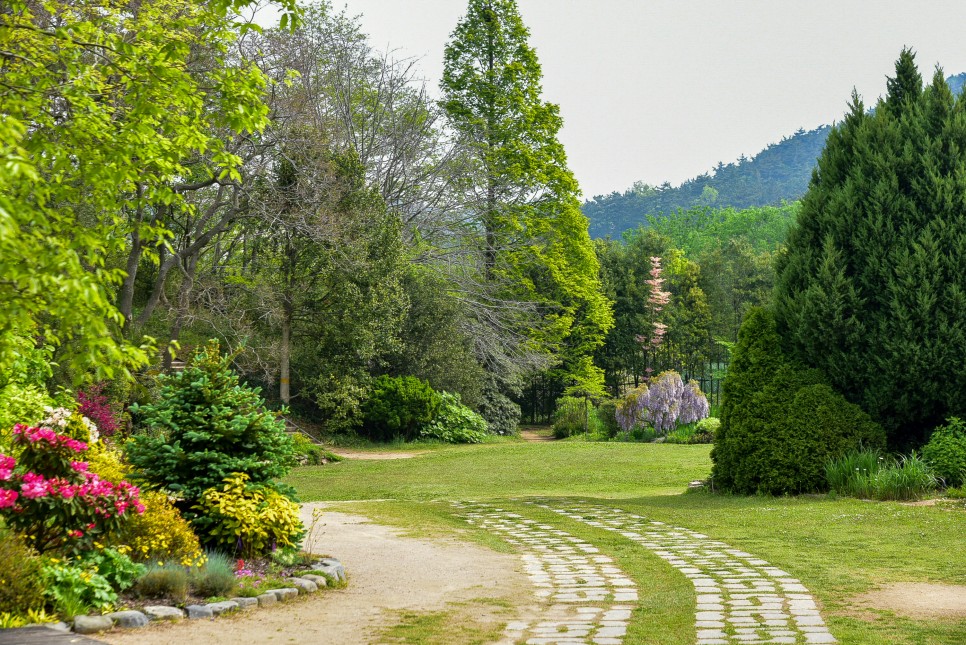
[{"x1": 288, "y1": 442, "x2": 966, "y2": 645}]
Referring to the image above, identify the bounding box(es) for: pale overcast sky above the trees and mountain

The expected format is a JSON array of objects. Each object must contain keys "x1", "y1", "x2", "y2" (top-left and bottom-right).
[{"x1": 318, "y1": 0, "x2": 966, "y2": 198}]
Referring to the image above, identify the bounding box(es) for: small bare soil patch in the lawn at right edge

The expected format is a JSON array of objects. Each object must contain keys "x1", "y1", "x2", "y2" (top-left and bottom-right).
[{"x1": 852, "y1": 582, "x2": 966, "y2": 618}]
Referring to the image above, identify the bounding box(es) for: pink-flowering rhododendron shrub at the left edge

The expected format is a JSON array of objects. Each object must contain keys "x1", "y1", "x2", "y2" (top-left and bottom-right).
[{"x1": 0, "y1": 425, "x2": 144, "y2": 553}]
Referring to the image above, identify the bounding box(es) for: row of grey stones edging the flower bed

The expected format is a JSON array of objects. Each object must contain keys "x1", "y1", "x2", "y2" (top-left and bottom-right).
[{"x1": 65, "y1": 558, "x2": 346, "y2": 634}]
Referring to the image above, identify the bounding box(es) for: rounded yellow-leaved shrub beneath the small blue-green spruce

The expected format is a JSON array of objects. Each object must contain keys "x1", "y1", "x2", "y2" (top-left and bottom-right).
[{"x1": 194, "y1": 473, "x2": 304, "y2": 558}]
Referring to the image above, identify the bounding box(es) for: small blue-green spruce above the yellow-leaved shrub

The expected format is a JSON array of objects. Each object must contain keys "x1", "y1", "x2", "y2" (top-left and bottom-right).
[{"x1": 127, "y1": 341, "x2": 293, "y2": 510}]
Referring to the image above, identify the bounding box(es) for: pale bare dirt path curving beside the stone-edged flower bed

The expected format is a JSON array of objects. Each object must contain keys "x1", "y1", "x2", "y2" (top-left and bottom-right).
[{"x1": 98, "y1": 505, "x2": 532, "y2": 645}]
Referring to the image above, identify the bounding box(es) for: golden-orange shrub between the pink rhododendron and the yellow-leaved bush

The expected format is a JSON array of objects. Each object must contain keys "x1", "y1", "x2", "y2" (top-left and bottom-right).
[{"x1": 122, "y1": 491, "x2": 205, "y2": 567}]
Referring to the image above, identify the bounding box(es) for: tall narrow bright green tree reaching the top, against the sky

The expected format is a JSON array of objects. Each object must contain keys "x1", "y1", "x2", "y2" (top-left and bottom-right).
[{"x1": 441, "y1": 0, "x2": 613, "y2": 392}]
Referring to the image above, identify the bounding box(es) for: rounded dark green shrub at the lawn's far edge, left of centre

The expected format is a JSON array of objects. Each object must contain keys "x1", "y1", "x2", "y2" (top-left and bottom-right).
[{"x1": 362, "y1": 376, "x2": 442, "y2": 441}]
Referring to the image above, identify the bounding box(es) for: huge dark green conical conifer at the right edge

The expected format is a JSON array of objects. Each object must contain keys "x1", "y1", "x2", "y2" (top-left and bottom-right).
[{"x1": 775, "y1": 50, "x2": 966, "y2": 446}]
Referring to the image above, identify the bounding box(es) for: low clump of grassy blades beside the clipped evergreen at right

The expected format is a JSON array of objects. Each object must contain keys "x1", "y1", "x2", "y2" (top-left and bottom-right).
[{"x1": 825, "y1": 449, "x2": 937, "y2": 500}]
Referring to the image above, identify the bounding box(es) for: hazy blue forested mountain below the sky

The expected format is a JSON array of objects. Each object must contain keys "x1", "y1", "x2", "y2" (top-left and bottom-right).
[{"x1": 582, "y1": 73, "x2": 966, "y2": 239}]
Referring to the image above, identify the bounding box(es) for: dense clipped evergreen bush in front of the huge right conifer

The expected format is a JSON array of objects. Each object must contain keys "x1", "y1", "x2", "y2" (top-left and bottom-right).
[{"x1": 711, "y1": 309, "x2": 884, "y2": 495}]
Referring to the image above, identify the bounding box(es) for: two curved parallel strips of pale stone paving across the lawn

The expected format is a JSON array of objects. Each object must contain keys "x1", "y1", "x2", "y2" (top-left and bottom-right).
[{"x1": 461, "y1": 499, "x2": 837, "y2": 645}]
